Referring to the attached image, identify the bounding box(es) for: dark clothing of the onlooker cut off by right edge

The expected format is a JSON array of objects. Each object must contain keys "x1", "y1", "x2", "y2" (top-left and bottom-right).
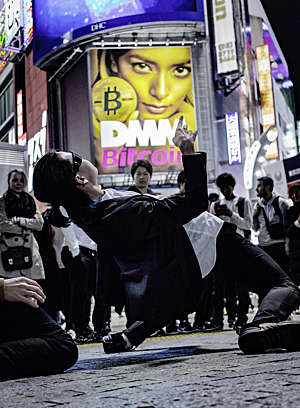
[{"x1": 285, "y1": 203, "x2": 300, "y2": 285}]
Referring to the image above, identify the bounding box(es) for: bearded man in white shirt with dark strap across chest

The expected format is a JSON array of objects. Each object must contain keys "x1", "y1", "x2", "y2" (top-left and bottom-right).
[{"x1": 253, "y1": 176, "x2": 290, "y2": 272}]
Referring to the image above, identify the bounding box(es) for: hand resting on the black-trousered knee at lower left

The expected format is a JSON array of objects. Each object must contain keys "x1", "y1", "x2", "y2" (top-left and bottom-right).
[{"x1": 4, "y1": 277, "x2": 46, "y2": 309}]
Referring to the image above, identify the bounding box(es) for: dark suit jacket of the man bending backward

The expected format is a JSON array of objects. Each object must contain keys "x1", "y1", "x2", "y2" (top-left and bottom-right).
[{"x1": 67, "y1": 153, "x2": 208, "y2": 325}]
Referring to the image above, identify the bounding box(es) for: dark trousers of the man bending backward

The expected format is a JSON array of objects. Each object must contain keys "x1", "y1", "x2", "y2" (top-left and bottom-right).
[{"x1": 124, "y1": 223, "x2": 300, "y2": 346}]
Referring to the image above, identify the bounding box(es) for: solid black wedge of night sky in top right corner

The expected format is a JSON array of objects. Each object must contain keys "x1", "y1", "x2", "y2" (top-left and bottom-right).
[{"x1": 262, "y1": 0, "x2": 300, "y2": 120}]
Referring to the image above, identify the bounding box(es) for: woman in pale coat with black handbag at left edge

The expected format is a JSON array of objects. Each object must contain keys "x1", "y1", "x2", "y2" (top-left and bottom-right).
[{"x1": 0, "y1": 169, "x2": 45, "y2": 282}]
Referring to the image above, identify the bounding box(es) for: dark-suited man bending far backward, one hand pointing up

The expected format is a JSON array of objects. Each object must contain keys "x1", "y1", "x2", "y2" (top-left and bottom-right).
[{"x1": 33, "y1": 118, "x2": 300, "y2": 353}]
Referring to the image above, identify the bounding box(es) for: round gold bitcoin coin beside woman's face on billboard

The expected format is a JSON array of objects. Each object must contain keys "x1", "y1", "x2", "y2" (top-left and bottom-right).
[{"x1": 92, "y1": 77, "x2": 137, "y2": 122}]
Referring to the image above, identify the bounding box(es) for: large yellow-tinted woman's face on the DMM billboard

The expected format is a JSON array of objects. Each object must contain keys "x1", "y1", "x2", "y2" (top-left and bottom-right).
[{"x1": 111, "y1": 47, "x2": 192, "y2": 119}]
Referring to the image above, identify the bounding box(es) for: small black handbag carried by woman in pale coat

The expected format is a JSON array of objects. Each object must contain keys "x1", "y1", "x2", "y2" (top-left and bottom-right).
[{"x1": 1, "y1": 236, "x2": 32, "y2": 272}]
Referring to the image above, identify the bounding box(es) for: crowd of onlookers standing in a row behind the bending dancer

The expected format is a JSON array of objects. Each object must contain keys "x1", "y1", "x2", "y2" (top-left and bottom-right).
[{"x1": 0, "y1": 160, "x2": 300, "y2": 344}]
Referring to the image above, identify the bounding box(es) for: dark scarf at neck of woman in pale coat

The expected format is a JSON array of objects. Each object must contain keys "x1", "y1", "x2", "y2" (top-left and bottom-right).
[{"x1": 3, "y1": 190, "x2": 36, "y2": 218}]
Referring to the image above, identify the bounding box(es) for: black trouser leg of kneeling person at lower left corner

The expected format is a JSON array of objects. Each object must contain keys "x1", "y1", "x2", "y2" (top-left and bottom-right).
[{"x1": 0, "y1": 302, "x2": 78, "y2": 381}]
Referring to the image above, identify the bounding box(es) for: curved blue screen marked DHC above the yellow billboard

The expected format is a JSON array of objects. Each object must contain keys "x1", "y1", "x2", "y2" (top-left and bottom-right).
[{"x1": 33, "y1": 0, "x2": 204, "y2": 63}]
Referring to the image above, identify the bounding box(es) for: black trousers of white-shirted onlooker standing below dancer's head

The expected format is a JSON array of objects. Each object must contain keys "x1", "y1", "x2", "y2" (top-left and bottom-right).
[{"x1": 62, "y1": 246, "x2": 98, "y2": 334}]
